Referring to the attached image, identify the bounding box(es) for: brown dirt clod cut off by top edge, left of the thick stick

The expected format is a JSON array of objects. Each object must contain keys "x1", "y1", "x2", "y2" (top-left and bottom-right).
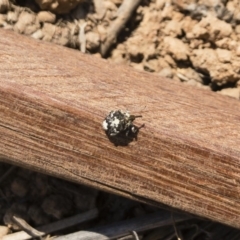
[{"x1": 35, "y1": 0, "x2": 83, "y2": 14}]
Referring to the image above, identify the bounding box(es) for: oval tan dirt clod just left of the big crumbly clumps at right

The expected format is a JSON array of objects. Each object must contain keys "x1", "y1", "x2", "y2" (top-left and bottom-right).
[{"x1": 164, "y1": 37, "x2": 189, "y2": 61}]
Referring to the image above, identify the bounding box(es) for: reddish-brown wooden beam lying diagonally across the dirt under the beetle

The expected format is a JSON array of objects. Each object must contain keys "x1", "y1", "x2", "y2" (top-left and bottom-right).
[{"x1": 0, "y1": 30, "x2": 240, "y2": 227}]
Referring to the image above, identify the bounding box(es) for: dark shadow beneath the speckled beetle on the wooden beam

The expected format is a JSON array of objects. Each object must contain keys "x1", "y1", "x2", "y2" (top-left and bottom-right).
[{"x1": 105, "y1": 124, "x2": 144, "y2": 147}]
